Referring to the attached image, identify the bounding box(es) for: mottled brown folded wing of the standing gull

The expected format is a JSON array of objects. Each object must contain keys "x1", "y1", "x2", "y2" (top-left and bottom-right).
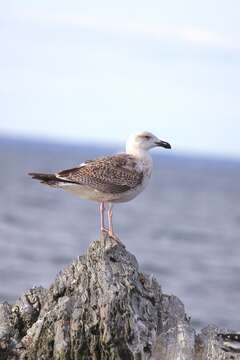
[{"x1": 57, "y1": 154, "x2": 143, "y2": 193}]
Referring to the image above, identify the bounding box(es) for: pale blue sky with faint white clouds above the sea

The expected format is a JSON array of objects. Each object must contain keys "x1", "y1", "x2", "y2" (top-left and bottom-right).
[{"x1": 0, "y1": 0, "x2": 240, "y2": 157}]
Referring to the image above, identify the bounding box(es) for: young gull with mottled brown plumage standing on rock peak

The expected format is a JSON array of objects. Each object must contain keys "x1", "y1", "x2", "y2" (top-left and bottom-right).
[{"x1": 29, "y1": 131, "x2": 171, "y2": 240}]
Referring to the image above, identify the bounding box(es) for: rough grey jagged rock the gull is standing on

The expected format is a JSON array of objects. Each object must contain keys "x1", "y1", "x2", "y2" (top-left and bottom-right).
[{"x1": 0, "y1": 235, "x2": 240, "y2": 360}]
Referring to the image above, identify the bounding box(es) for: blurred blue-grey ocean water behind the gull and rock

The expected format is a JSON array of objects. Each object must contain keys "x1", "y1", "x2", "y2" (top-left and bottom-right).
[{"x1": 0, "y1": 138, "x2": 240, "y2": 330}]
